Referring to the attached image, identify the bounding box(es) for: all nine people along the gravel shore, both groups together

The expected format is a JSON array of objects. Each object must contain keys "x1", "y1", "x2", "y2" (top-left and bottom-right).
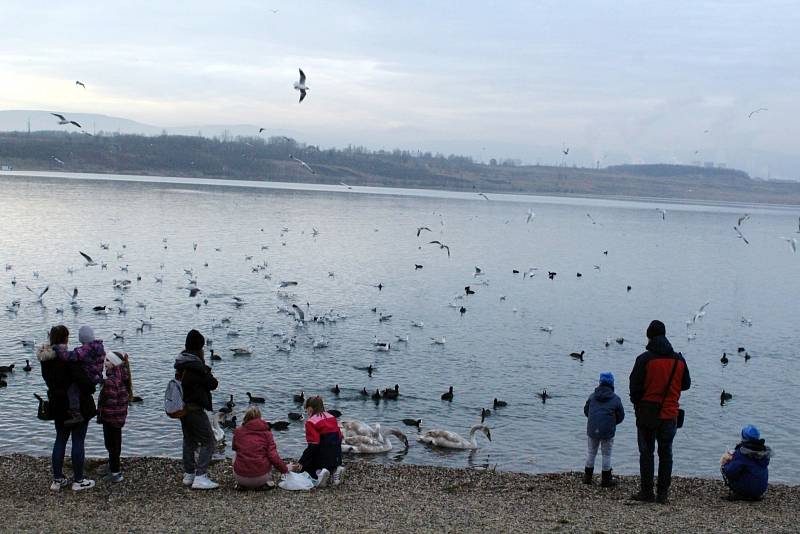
[{"x1": 37, "y1": 320, "x2": 771, "y2": 504}]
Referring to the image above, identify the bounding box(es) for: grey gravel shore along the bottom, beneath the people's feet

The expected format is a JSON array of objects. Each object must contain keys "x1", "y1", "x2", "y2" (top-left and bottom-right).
[{"x1": 0, "y1": 455, "x2": 800, "y2": 533}]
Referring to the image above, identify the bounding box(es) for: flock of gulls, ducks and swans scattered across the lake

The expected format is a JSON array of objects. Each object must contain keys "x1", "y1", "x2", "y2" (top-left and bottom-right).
[{"x1": 0, "y1": 203, "x2": 800, "y2": 462}]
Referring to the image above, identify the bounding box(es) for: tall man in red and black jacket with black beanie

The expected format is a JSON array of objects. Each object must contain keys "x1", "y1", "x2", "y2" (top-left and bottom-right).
[{"x1": 630, "y1": 321, "x2": 691, "y2": 504}]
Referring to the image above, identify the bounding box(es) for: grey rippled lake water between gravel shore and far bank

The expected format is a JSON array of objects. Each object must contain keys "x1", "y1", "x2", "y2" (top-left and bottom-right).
[{"x1": 0, "y1": 173, "x2": 800, "y2": 484}]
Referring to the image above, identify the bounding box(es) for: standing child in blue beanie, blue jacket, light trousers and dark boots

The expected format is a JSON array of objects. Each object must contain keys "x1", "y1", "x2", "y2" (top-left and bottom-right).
[{"x1": 583, "y1": 372, "x2": 625, "y2": 488}]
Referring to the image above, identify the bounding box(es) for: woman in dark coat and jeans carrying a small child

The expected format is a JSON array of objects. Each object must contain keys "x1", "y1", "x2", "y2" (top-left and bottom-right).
[{"x1": 37, "y1": 325, "x2": 96, "y2": 491}]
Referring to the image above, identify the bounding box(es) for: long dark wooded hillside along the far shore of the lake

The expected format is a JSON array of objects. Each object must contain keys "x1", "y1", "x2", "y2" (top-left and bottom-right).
[{"x1": 0, "y1": 130, "x2": 800, "y2": 205}]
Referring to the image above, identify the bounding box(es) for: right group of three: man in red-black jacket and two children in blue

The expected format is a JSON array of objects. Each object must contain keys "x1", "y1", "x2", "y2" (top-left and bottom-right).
[{"x1": 583, "y1": 320, "x2": 772, "y2": 504}]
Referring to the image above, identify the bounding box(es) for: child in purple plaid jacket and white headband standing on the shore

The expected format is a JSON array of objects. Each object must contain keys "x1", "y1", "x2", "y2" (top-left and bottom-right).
[{"x1": 97, "y1": 352, "x2": 132, "y2": 482}]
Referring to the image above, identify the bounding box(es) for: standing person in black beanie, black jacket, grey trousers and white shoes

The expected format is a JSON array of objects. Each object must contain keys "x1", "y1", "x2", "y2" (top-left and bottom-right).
[{"x1": 175, "y1": 330, "x2": 219, "y2": 489}]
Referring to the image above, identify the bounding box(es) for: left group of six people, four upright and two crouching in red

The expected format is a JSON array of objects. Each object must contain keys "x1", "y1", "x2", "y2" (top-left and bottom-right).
[{"x1": 37, "y1": 325, "x2": 344, "y2": 491}]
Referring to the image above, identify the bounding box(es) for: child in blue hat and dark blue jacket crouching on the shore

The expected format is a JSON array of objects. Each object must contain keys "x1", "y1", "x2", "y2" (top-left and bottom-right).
[{"x1": 721, "y1": 425, "x2": 772, "y2": 501}]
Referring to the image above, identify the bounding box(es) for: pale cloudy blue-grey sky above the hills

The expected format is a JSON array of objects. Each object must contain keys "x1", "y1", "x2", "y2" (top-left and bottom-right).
[{"x1": 0, "y1": 0, "x2": 800, "y2": 179}]
